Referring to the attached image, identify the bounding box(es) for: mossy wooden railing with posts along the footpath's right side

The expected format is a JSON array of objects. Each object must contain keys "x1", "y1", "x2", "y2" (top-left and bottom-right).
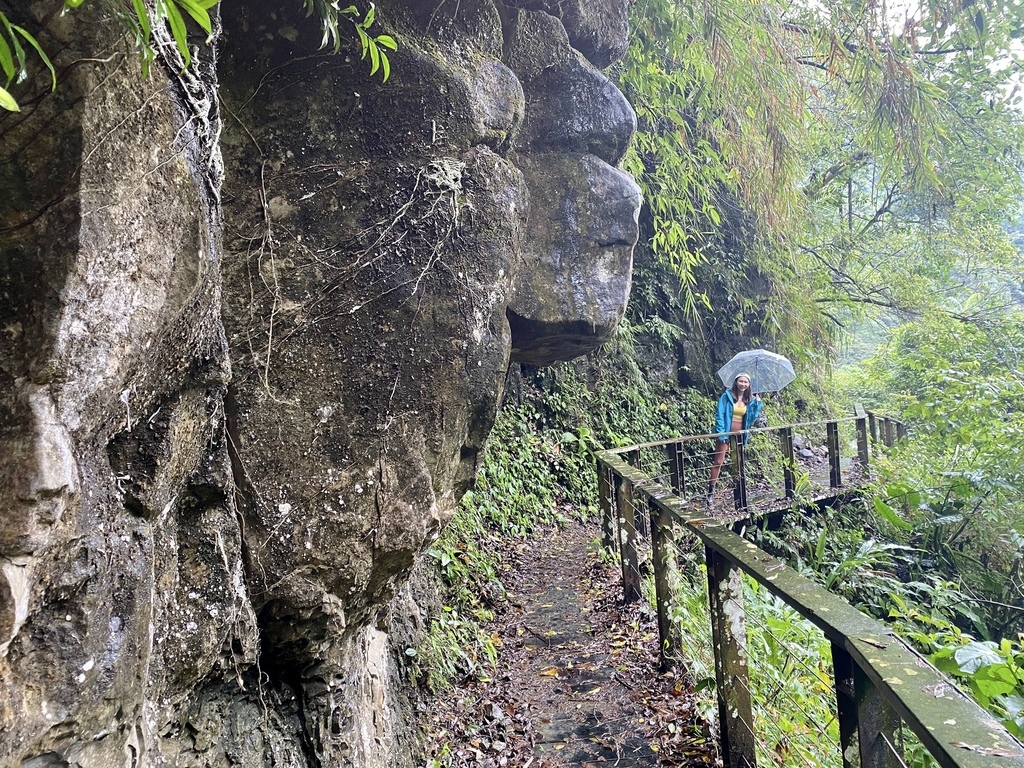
[{"x1": 597, "y1": 411, "x2": 1024, "y2": 768}]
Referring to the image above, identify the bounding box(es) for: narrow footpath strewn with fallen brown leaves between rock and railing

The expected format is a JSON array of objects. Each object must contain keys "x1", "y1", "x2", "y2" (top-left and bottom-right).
[{"x1": 419, "y1": 522, "x2": 715, "y2": 768}]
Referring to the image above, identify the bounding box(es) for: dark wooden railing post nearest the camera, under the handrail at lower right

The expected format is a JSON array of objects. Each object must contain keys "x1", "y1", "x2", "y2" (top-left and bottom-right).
[{"x1": 833, "y1": 643, "x2": 905, "y2": 768}]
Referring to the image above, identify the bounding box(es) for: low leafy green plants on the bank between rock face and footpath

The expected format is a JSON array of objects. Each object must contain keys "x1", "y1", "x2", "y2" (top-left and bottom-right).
[{"x1": 414, "y1": 339, "x2": 713, "y2": 690}]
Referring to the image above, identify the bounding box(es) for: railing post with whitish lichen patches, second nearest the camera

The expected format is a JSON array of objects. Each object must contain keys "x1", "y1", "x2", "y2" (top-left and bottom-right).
[{"x1": 705, "y1": 547, "x2": 756, "y2": 768}]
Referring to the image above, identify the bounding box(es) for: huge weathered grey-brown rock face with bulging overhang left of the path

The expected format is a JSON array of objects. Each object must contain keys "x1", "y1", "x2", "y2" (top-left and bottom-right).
[{"x1": 0, "y1": 0, "x2": 640, "y2": 768}]
